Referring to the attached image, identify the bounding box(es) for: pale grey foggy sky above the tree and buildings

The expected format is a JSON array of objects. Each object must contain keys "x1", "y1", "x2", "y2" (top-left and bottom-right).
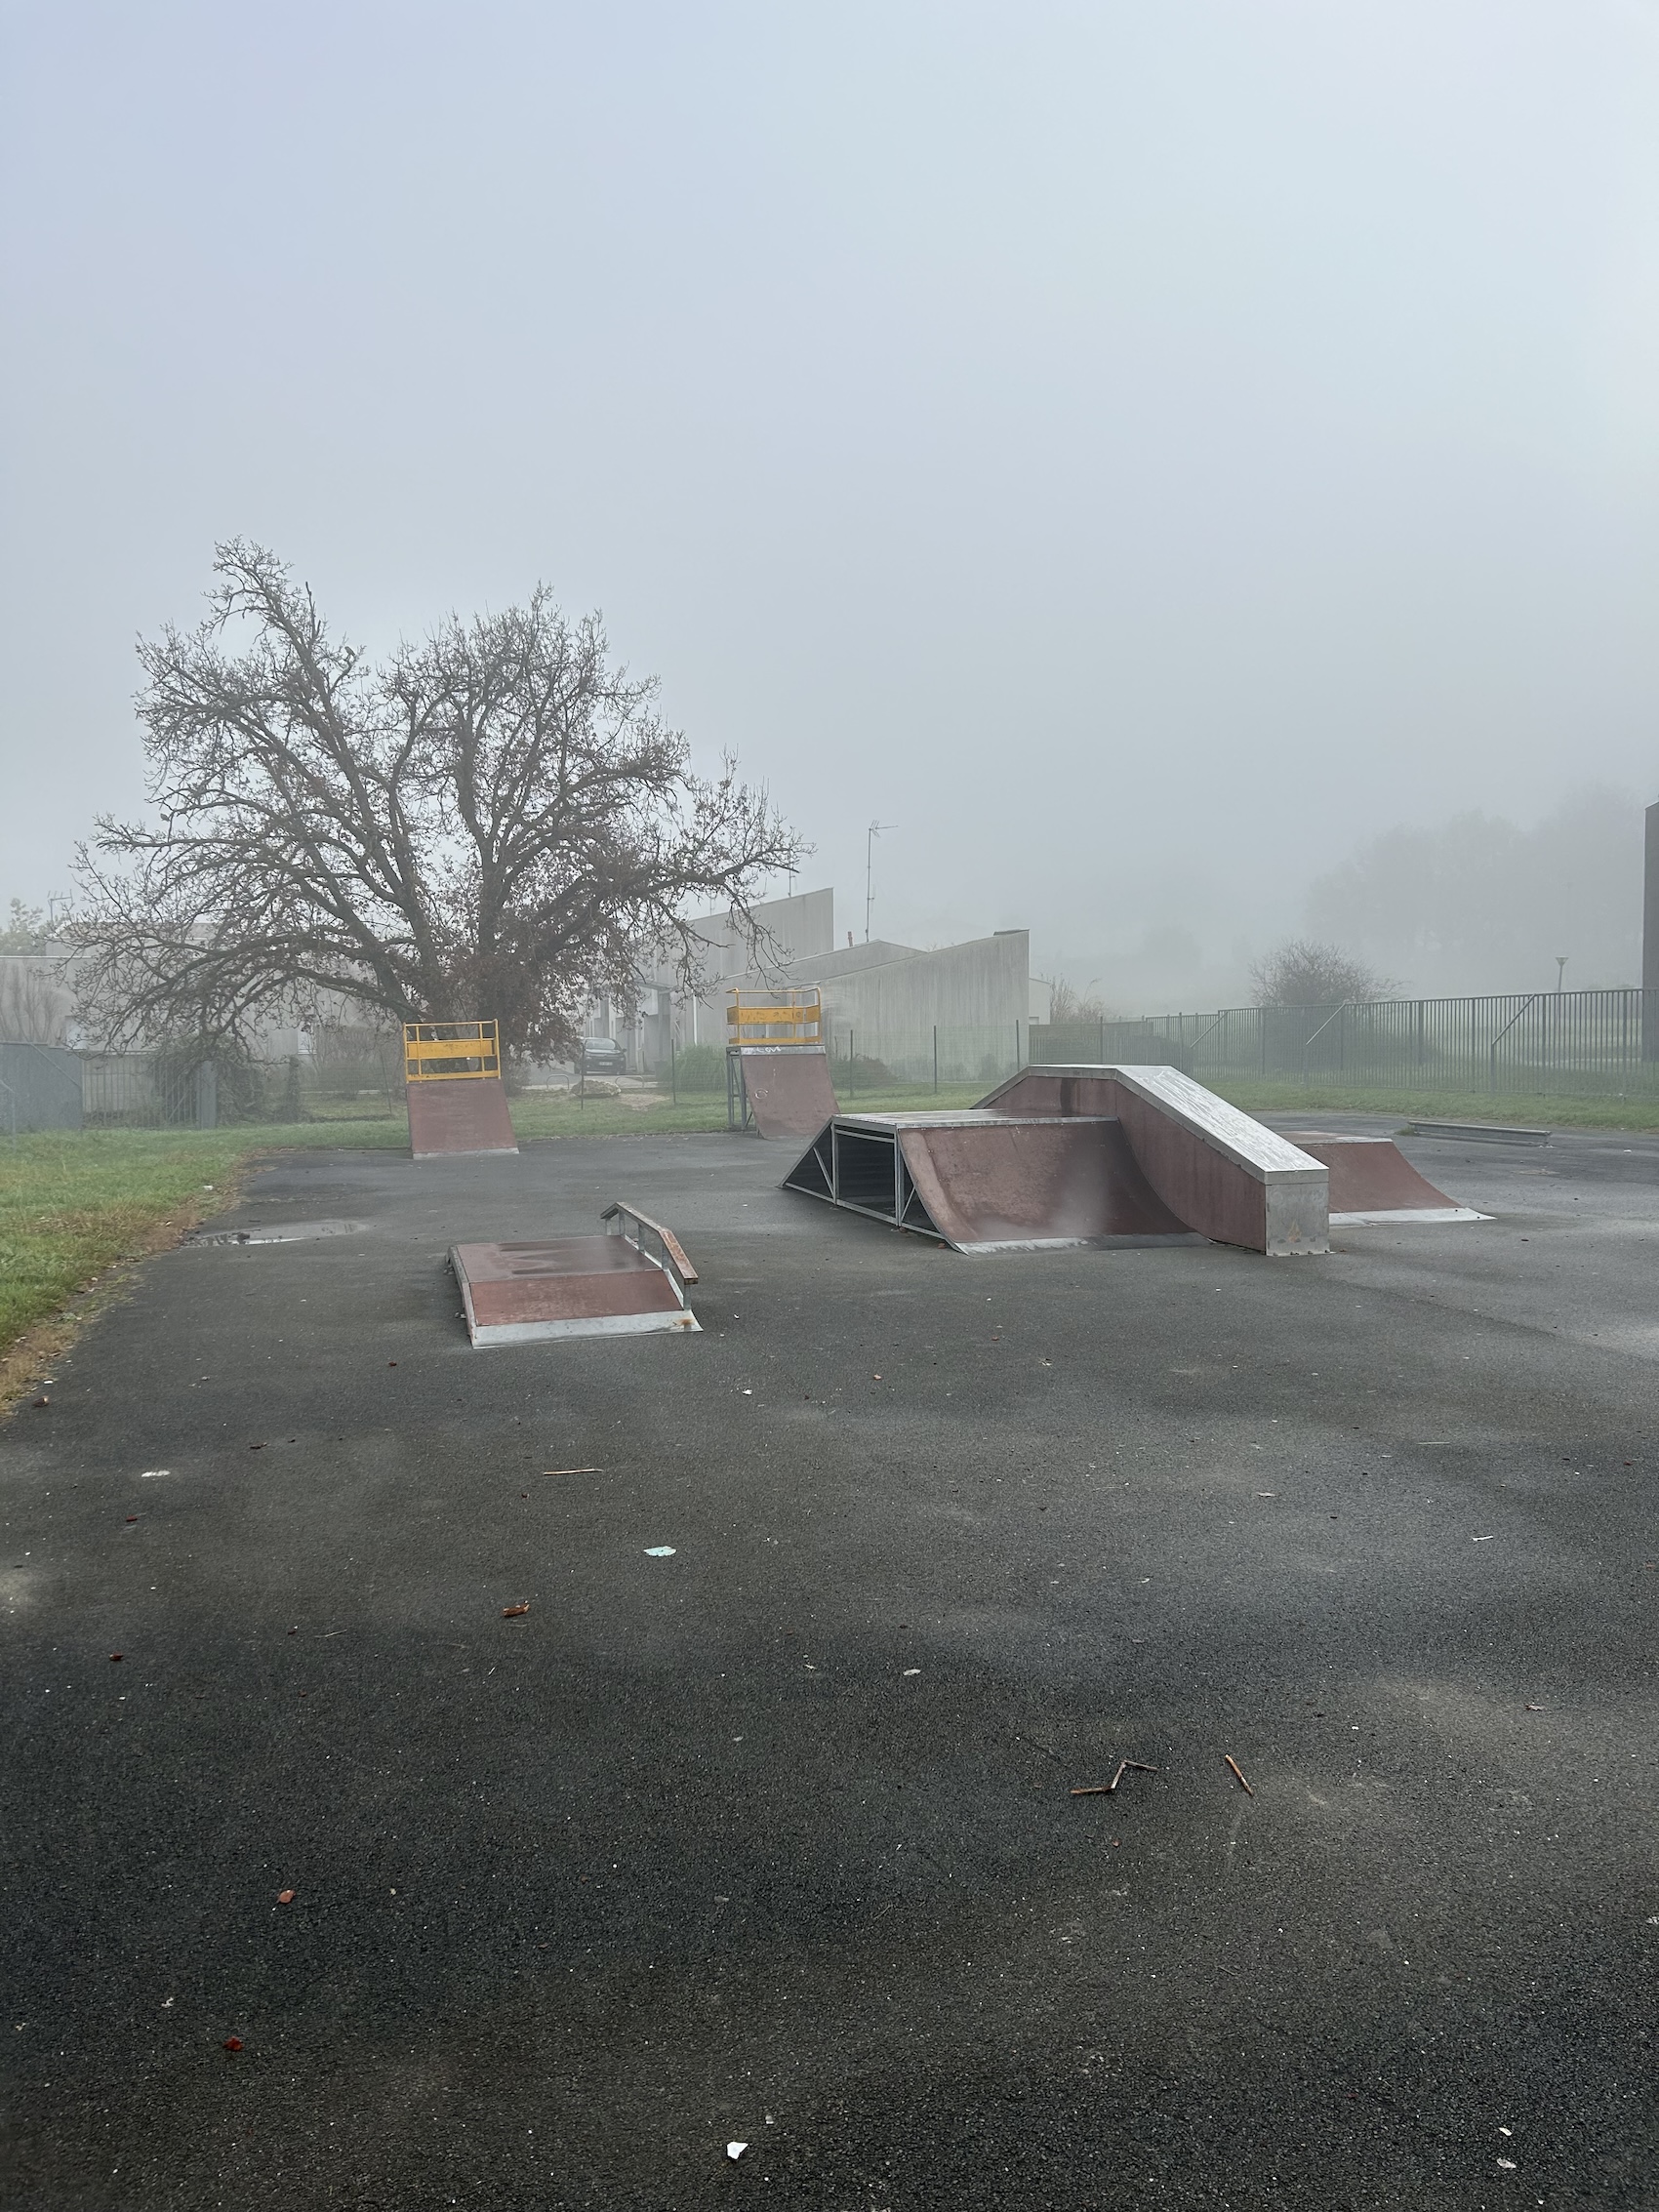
[{"x1": 0, "y1": 0, "x2": 1659, "y2": 1011}]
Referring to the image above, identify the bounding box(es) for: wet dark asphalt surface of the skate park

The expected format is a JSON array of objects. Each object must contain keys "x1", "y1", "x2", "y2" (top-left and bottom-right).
[{"x1": 0, "y1": 1115, "x2": 1659, "y2": 2212}]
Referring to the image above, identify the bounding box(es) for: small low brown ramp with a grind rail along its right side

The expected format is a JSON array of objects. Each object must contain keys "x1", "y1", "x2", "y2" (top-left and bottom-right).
[{"x1": 449, "y1": 1206, "x2": 697, "y2": 1349}]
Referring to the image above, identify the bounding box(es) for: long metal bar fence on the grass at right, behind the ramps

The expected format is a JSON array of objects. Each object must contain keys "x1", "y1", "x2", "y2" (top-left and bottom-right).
[{"x1": 1029, "y1": 991, "x2": 1659, "y2": 1097}]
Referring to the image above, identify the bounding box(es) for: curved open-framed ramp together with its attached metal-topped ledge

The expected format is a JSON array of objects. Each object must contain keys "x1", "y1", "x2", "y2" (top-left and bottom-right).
[{"x1": 783, "y1": 1066, "x2": 1329, "y2": 1257}]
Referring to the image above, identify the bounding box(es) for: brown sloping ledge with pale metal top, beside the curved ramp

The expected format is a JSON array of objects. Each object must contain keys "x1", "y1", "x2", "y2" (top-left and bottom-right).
[{"x1": 976, "y1": 1066, "x2": 1329, "y2": 1259}]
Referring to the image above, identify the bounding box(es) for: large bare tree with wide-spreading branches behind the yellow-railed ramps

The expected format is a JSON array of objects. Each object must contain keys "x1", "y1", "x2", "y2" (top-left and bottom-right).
[{"x1": 71, "y1": 542, "x2": 807, "y2": 1053}]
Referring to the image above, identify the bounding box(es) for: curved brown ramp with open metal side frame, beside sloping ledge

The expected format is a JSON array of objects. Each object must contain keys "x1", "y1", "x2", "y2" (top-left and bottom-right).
[{"x1": 783, "y1": 1112, "x2": 1203, "y2": 1252}]
